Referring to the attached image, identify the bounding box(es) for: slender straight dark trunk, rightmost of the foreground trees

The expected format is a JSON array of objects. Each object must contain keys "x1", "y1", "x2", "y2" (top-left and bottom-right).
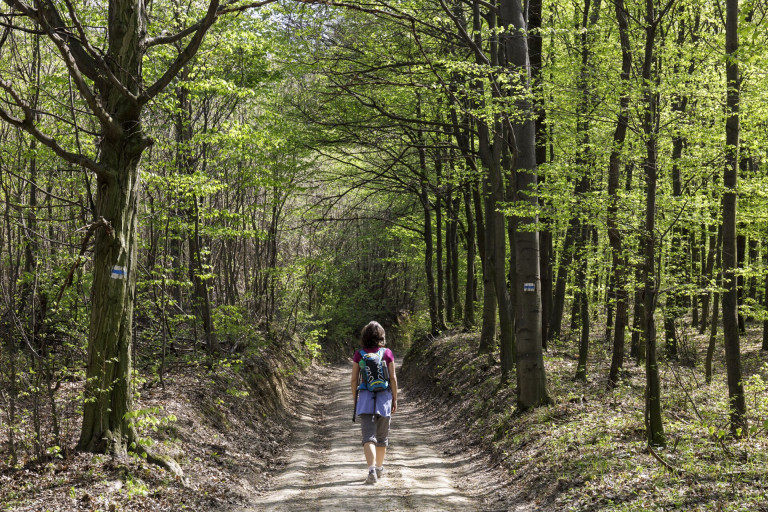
[{"x1": 723, "y1": 0, "x2": 747, "y2": 437}]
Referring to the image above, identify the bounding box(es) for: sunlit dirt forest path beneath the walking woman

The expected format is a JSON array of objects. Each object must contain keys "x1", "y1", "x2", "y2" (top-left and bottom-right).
[{"x1": 243, "y1": 366, "x2": 481, "y2": 512}]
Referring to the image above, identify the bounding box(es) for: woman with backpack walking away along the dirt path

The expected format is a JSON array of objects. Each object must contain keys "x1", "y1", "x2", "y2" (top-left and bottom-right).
[{"x1": 351, "y1": 322, "x2": 397, "y2": 484}]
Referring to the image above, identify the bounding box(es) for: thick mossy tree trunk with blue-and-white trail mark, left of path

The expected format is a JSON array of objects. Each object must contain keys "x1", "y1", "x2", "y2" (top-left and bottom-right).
[{"x1": 77, "y1": 0, "x2": 150, "y2": 455}]
